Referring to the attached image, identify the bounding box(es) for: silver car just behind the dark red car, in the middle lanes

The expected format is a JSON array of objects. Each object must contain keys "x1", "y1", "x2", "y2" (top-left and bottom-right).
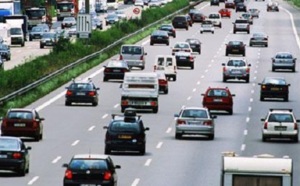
[{"x1": 174, "y1": 107, "x2": 217, "y2": 140}]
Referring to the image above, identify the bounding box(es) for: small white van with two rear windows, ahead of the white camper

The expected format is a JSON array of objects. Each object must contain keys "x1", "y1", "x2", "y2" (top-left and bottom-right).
[{"x1": 154, "y1": 55, "x2": 177, "y2": 81}]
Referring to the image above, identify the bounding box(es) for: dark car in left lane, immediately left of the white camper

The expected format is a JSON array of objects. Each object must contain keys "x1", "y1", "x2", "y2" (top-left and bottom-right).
[{"x1": 65, "y1": 79, "x2": 100, "y2": 106}]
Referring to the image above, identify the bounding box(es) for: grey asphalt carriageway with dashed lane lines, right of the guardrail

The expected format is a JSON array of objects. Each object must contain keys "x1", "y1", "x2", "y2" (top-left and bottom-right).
[{"x1": 0, "y1": 0, "x2": 300, "y2": 186}]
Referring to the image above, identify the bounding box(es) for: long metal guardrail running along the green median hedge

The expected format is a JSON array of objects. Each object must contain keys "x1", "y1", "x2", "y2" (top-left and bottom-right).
[{"x1": 0, "y1": 0, "x2": 204, "y2": 105}]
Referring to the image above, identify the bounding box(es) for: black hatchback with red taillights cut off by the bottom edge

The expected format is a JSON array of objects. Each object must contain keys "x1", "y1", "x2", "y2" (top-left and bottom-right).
[{"x1": 63, "y1": 154, "x2": 121, "y2": 186}]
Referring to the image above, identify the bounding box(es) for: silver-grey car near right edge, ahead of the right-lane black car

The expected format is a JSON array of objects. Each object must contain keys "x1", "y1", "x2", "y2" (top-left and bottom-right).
[{"x1": 272, "y1": 52, "x2": 297, "y2": 72}]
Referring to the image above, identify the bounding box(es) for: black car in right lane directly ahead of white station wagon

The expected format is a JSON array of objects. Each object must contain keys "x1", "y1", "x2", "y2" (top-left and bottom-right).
[{"x1": 259, "y1": 77, "x2": 290, "y2": 101}]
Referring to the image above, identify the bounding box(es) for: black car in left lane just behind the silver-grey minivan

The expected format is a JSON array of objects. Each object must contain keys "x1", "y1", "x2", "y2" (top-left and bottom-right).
[{"x1": 103, "y1": 60, "x2": 130, "y2": 81}]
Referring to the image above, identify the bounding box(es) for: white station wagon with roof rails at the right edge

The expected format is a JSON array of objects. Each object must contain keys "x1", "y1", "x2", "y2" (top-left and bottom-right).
[{"x1": 261, "y1": 108, "x2": 300, "y2": 143}]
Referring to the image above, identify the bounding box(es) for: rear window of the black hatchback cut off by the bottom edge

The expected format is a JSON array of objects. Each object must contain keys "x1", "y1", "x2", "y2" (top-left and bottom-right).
[{"x1": 69, "y1": 159, "x2": 108, "y2": 170}]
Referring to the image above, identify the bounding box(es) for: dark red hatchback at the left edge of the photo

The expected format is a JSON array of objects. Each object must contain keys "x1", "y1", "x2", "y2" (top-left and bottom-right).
[{"x1": 1, "y1": 108, "x2": 45, "y2": 141}]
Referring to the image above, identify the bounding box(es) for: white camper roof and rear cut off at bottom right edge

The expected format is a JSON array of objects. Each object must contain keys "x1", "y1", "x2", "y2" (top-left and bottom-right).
[{"x1": 221, "y1": 152, "x2": 293, "y2": 186}]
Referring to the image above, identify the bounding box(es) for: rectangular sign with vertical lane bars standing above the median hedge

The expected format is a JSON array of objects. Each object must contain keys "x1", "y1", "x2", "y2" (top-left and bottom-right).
[{"x1": 76, "y1": 14, "x2": 92, "y2": 38}]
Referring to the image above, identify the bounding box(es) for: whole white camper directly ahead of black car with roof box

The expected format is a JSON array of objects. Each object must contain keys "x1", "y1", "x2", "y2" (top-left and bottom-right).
[{"x1": 121, "y1": 72, "x2": 159, "y2": 113}]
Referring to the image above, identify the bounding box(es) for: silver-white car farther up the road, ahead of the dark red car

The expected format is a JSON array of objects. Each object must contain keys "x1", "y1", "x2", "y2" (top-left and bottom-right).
[{"x1": 222, "y1": 59, "x2": 251, "y2": 83}]
